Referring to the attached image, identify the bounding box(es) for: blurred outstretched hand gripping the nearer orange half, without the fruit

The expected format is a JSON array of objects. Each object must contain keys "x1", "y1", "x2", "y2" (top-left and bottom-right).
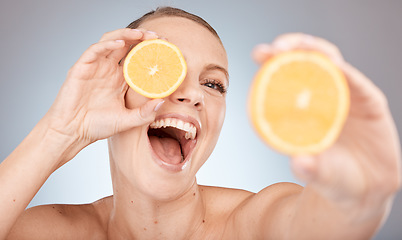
[{"x1": 253, "y1": 33, "x2": 401, "y2": 217}]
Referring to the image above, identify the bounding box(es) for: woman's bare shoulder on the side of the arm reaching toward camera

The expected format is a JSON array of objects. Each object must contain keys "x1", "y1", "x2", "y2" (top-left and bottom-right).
[{"x1": 218, "y1": 183, "x2": 303, "y2": 239}]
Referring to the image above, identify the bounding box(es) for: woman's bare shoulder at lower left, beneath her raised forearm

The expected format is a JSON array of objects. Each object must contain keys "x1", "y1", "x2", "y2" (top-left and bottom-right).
[{"x1": 7, "y1": 197, "x2": 111, "y2": 239}]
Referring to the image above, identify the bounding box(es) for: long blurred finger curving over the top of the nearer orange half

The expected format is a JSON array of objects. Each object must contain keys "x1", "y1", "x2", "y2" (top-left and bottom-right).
[{"x1": 272, "y1": 33, "x2": 344, "y2": 65}]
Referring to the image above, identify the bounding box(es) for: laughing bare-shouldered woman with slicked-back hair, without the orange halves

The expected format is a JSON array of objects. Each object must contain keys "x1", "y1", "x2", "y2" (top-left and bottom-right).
[{"x1": 0, "y1": 8, "x2": 400, "y2": 239}]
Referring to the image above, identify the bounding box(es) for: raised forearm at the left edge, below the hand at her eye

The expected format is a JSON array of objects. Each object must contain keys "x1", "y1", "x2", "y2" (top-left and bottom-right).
[{"x1": 0, "y1": 120, "x2": 80, "y2": 239}]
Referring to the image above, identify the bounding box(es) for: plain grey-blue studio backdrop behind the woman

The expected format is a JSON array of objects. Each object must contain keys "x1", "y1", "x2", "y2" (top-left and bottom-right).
[{"x1": 0, "y1": 0, "x2": 402, "y2": 239}]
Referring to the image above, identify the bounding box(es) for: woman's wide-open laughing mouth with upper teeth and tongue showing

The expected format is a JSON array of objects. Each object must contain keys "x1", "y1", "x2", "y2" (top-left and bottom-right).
[{"x1": 148, "y1": 117, "x2": 197, "y2": 171}]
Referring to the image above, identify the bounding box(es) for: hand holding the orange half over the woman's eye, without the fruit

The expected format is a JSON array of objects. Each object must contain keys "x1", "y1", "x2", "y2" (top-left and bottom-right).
[{"x1": 45, "y1": 28, "x2": 162, "y2": 154}]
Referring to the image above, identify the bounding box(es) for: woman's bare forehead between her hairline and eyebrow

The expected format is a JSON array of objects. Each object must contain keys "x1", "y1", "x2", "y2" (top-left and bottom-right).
[{"x1": 139, "y1": 17, "x2": 228, "y2": 69}]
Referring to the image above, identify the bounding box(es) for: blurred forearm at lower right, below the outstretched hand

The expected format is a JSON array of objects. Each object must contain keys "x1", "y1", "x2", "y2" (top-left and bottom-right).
[{"x1": 286, "y1": 187, "x2": 392, "y2": 239}]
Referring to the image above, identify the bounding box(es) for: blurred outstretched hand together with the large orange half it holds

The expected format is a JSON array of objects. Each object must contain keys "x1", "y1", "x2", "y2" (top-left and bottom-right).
[{"x1": 249, "y1": 33, "x2": 401, "y2": 226}]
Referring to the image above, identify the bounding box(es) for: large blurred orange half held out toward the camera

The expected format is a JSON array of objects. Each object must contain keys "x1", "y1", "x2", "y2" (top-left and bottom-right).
[{"x1": 248, "y1": 50, "x2": 350, "y2": 155}]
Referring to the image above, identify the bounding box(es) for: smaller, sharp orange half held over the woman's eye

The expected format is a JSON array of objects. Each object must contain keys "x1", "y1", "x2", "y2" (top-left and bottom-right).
[{"x1": 123, "y1": 39, "x2": 187, "y2": 98}]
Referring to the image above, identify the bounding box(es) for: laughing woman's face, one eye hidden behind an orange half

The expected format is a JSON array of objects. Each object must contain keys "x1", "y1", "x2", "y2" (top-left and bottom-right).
[{"x1": 109, "y1": 17, "x2": 229, "y2": 199}]
